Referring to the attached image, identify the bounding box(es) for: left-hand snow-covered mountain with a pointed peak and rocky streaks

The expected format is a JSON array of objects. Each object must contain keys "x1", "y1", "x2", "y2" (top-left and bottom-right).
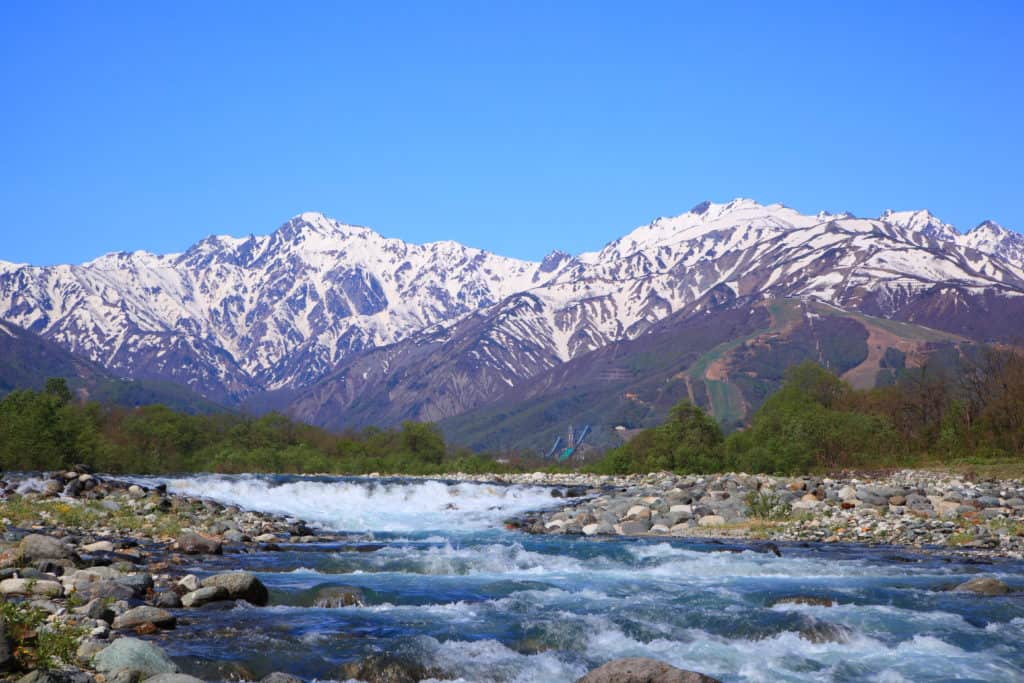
[{"x1": 0, "y1": 213, "x2": 541, "y2": 399}]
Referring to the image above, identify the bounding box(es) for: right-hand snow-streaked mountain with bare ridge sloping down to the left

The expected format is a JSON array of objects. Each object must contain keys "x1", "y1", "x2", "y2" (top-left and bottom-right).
[{"x1": 278, "y1": 200, "x2": 1024, "y2": 427}]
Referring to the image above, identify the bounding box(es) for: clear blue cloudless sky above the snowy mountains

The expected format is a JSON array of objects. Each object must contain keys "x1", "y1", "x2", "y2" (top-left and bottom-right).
[{"x1": 0, "y1": 0, "x2": 1024, "y2": 263}]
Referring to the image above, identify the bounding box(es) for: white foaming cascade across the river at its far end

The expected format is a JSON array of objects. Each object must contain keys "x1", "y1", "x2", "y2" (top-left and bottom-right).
[{"x1": 151, "y1": 475, "x2": 554, "y2": 531}]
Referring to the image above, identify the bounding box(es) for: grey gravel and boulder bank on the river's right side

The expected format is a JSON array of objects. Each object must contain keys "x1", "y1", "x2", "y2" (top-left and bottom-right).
[{"x1": 469, "y1": 470, "x2": 1024, "y2": 558}]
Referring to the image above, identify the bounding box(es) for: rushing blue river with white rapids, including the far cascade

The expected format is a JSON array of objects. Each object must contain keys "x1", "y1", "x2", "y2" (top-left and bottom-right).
[{"x1": 150, "y1": 476, "x2": 1024, "y2": 683}]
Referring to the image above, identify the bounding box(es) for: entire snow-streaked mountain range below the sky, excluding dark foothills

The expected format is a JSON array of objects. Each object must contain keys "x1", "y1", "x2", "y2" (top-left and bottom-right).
[{"x1": 0, "y1": 200, "x2": 1024, "y2": 421}]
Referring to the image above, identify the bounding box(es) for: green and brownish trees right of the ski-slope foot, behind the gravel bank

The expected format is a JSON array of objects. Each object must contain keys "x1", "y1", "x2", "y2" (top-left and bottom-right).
[{"x1": 591, "y1": 348, "x2": 1024, "y2": 474}]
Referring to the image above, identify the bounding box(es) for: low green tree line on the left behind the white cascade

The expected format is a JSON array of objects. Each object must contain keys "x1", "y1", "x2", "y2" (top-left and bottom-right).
[{"x1": 0, "y1": 379, "x2": 503, "y2": 474}]
